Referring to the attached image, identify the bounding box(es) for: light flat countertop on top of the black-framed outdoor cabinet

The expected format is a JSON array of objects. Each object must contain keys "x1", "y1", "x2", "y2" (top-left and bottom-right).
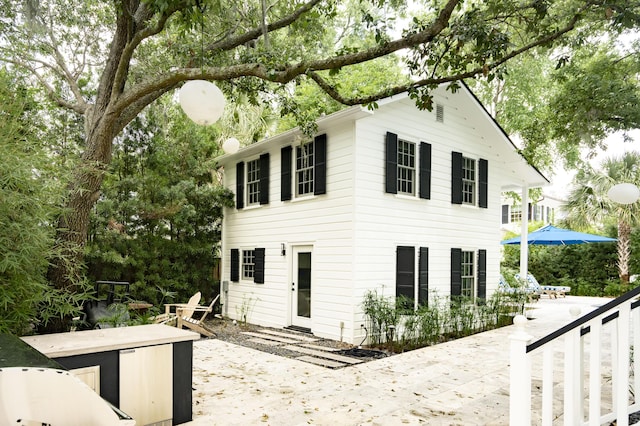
[{"x1": 21, "y1": 324, "x2": 200, "y2": 358}]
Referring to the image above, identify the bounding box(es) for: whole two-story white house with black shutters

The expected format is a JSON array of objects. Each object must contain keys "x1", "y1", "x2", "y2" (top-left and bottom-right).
[{"x1": 218, "y1": 86, "x2": 548, "y2": 343}]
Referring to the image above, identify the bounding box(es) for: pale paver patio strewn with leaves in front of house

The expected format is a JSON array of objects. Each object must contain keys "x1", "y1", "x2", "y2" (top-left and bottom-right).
[{"x1": 187, "y1": 296, "x2": 610, "y2": 425}]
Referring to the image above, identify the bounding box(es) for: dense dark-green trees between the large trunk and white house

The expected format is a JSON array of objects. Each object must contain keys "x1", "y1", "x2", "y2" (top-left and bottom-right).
[{"x1": 86, "y1": 98, "x2": 233, "y2": 304}]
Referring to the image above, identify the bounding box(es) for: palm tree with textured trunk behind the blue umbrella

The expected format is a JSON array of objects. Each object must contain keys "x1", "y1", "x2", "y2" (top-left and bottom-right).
[{"x1": 564, "y1": 152, "x2": 640, "y2": 285}]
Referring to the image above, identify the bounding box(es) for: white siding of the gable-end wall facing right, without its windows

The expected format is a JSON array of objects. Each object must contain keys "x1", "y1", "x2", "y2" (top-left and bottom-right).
[{"x1": 354, "y1": 88, "x2": 500, "y2": 338}]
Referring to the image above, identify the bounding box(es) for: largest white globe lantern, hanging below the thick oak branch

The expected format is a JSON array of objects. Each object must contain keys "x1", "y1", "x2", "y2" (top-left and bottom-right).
[{"x1": 179, "y1": 80, "x2": 225, "y2": 126}]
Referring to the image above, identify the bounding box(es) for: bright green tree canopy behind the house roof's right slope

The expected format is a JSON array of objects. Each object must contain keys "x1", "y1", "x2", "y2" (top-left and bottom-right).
[{"x1": 469, "y1": 40, "x2": 640, "y2": 172}]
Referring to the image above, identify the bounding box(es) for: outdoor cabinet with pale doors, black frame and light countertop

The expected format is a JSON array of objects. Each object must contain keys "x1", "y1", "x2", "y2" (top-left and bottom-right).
[{"x1": 22, "y1": 324, "x2": 200, "y2": 426}]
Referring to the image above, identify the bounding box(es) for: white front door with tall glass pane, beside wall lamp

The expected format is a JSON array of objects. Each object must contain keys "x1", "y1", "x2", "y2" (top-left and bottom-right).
[{"x1": 291, "y1": 246, "x2": 313, "y2": 329}]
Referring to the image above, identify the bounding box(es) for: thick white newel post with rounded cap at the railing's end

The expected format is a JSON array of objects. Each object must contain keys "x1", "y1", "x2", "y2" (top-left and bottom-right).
[{"x1": 509, "y1": 315, "x2": 532, "y2": 426}]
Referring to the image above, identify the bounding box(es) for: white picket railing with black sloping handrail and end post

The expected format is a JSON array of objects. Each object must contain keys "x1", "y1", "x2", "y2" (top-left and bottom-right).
[{"x1": 509, "y1": 287, "x2": 640, "y2": 426}]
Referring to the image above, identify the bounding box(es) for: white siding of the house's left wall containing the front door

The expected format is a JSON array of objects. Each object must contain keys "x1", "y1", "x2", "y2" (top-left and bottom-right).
[{"x1": 222, "y1": 121, "x2": 354, "y2": 338}]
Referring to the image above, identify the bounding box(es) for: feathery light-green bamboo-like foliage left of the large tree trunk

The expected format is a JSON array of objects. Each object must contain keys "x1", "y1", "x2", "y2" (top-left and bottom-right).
[{"x1": 0, "y1": 70, "x2": 89, "y2": 335}]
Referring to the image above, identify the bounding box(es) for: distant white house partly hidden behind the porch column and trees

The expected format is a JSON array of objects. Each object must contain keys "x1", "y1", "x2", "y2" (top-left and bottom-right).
[{"x1": 500, "y1": 194, "x2": 566, "y2": 233}]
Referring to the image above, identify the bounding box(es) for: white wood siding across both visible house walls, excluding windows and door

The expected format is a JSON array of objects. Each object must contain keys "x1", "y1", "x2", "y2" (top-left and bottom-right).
[{"x1": 222, "y1": 85, "x2": 539, "y2": 343}]
